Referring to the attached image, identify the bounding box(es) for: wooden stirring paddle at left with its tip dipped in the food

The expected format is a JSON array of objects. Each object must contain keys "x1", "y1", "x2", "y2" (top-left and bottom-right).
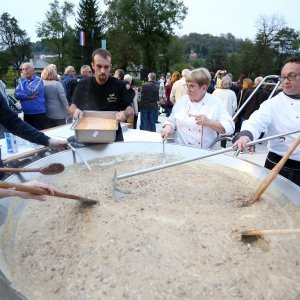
[{"x1": 0, "y1": 182, "x2": 98, "y2": 204}]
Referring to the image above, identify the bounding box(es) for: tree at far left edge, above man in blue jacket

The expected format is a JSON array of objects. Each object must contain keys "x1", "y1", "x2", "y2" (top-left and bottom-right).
[{"x1": 0, "y1": 13, "x2": 31, "y2": 74}]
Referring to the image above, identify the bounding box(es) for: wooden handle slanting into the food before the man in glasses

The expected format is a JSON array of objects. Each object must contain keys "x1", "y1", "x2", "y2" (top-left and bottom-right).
[{"x1": 247, "y1": 136, "x2": 300, "y2": 206}]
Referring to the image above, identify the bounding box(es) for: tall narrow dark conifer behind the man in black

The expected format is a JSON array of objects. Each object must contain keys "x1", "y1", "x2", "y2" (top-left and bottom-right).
[{"x1": 76, "y1": 0, "x2": 106, "y2": 64}]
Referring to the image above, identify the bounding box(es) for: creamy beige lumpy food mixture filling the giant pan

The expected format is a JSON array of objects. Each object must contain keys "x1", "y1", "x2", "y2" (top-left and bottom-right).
[{"x1": 1, "y1": 155, "x2": 300, "y2": 300}]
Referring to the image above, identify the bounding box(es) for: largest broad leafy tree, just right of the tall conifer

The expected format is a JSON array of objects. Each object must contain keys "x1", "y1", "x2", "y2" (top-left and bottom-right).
[{"x1": 105, "y1": 0, "x2": 187, "y2": 71}]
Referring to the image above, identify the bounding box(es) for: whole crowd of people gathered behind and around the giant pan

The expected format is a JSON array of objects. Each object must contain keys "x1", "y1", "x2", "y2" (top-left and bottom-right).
[{"x1": 0, "y1": 48, "x2": 300, "y2": 202}]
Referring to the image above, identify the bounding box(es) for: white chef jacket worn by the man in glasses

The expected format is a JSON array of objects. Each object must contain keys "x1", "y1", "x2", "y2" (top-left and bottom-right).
[{"x1": 241, "y1": 92, "x2": 300, "y2": 161}]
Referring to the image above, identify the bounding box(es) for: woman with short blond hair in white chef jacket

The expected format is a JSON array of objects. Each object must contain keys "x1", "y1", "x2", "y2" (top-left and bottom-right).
[{"x1": 161, "y1": 68, "x2": 234, "y2": 149}]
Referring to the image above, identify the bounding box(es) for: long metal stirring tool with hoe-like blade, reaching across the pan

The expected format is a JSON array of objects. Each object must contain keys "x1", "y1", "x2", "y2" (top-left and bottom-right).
[{"x1": 113, "y1": 129, "x2": 300, "y2": 200}]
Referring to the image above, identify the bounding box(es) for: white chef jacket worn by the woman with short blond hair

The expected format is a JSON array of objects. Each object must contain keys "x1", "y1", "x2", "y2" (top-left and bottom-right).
[{"x1": 163, "y1": 93, "x2": 235, "y2": 149}]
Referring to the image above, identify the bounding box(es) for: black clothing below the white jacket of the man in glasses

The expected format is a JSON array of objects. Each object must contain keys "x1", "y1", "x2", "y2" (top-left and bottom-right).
[{"x1": 265, "y1": 152, "x2": 300, "y2": 186}]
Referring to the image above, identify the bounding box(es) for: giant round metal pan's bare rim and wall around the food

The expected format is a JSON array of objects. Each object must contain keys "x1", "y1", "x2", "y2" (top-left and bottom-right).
[{"x1": 0, "y1": 142, "x2": 300, "y2": 300}]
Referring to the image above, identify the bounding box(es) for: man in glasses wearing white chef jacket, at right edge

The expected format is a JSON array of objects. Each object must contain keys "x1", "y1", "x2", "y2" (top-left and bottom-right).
[{"x1": 234, "y1": 57, "x2": 300, "y2": 186}]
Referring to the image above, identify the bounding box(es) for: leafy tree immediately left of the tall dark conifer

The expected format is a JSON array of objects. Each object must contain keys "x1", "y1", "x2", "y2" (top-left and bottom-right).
[{"x1": 36, "y1": 0, "x2": 74, "y2": 70}]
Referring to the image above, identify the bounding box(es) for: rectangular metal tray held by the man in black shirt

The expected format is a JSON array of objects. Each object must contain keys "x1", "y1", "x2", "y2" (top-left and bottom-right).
[{"x1": 71, "y1": 110, "x2": 118, "y2": 143}]
